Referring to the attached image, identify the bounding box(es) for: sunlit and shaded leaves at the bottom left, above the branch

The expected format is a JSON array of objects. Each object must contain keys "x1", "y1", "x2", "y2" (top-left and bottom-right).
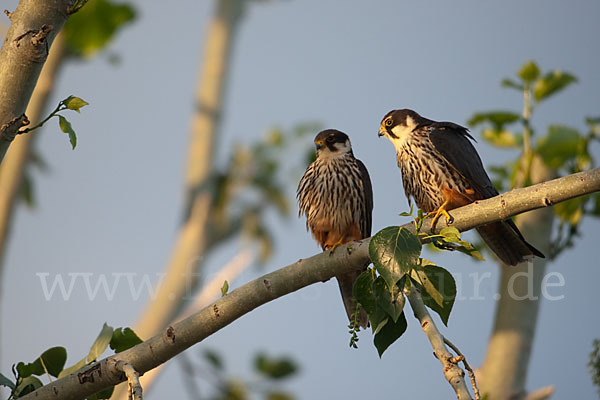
[{"x1": 0, "y1": 324, "x2": 142, "y2": 400}]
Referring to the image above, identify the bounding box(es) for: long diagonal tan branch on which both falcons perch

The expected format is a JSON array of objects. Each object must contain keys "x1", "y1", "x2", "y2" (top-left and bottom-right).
[{"x1": 23, "y1": 169, "x2": 600, "y2": 400}]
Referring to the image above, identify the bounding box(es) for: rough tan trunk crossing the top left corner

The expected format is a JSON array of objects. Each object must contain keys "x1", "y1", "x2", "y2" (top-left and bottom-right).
[{"x1": 0, "y1": 0, "x2": 73, "y2": 163}]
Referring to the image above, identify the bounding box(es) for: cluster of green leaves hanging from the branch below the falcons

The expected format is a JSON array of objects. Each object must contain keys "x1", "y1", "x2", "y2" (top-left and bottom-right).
[{"x1": 351, "y1": 225, "x2": 472, "y2": 357}]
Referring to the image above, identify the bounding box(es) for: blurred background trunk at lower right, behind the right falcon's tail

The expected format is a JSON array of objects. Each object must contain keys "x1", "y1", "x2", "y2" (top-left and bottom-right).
[{"x1": 479, "y1": 157, "x2": 554, "y2": 400}]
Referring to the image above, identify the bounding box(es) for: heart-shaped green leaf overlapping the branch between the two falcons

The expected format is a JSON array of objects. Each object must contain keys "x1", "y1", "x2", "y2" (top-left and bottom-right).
[{"x1": 369, "y1": 226, "x2": 421, "y2": 287}]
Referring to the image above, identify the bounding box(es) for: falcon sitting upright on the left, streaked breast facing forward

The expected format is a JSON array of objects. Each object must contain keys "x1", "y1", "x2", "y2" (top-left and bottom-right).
[{"x1": 297, "y1": 129, "x2": 373, "y2": 327}]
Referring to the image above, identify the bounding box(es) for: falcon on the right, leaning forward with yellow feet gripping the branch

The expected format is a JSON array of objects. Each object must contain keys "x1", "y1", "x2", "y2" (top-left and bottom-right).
[{"x1": 379, "y1": 109, "x2": 544, "y2": 265}]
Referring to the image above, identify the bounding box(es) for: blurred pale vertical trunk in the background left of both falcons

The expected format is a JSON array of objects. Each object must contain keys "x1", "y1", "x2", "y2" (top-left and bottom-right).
[{"x1": 135, "y1": 0, "x2": 243, "y2": 344}]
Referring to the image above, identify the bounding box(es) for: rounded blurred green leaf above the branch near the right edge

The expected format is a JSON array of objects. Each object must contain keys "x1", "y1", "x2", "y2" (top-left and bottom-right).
[{"x1": 537, "y1": 125, "x2": 586, "y2": 169}]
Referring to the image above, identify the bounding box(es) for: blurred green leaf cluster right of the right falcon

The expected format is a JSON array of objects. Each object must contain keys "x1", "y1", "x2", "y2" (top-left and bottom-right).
[{"x1": 468, "y1": 61, "x2": 600, "y2": 257}]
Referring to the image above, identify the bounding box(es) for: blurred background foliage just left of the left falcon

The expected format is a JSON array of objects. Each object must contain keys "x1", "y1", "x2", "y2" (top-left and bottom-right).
[{"x1": 206, "y1": 123, "x2": 318, "y2": 261}]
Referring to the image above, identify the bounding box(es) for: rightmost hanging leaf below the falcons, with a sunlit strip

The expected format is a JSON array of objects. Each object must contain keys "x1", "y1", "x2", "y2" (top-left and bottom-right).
[{"x1": 411, "y1": 260, "x2": 456, "y2": 326}]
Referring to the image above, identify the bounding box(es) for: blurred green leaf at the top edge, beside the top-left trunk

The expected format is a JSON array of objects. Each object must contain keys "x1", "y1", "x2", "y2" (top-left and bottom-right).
[{"x1": 63, "y1": 0, "x2": 135, "y2": 57}]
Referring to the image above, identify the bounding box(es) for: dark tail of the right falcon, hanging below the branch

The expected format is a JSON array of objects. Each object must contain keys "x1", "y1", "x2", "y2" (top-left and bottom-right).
[{"x1": 477, "y1": 219, "x2": 545, "y2": 265}]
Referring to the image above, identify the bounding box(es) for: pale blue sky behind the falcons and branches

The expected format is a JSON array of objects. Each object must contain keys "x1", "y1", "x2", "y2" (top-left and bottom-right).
[{"x1": 0, "y1": 0, "x2": 600, "y2": 399}]
